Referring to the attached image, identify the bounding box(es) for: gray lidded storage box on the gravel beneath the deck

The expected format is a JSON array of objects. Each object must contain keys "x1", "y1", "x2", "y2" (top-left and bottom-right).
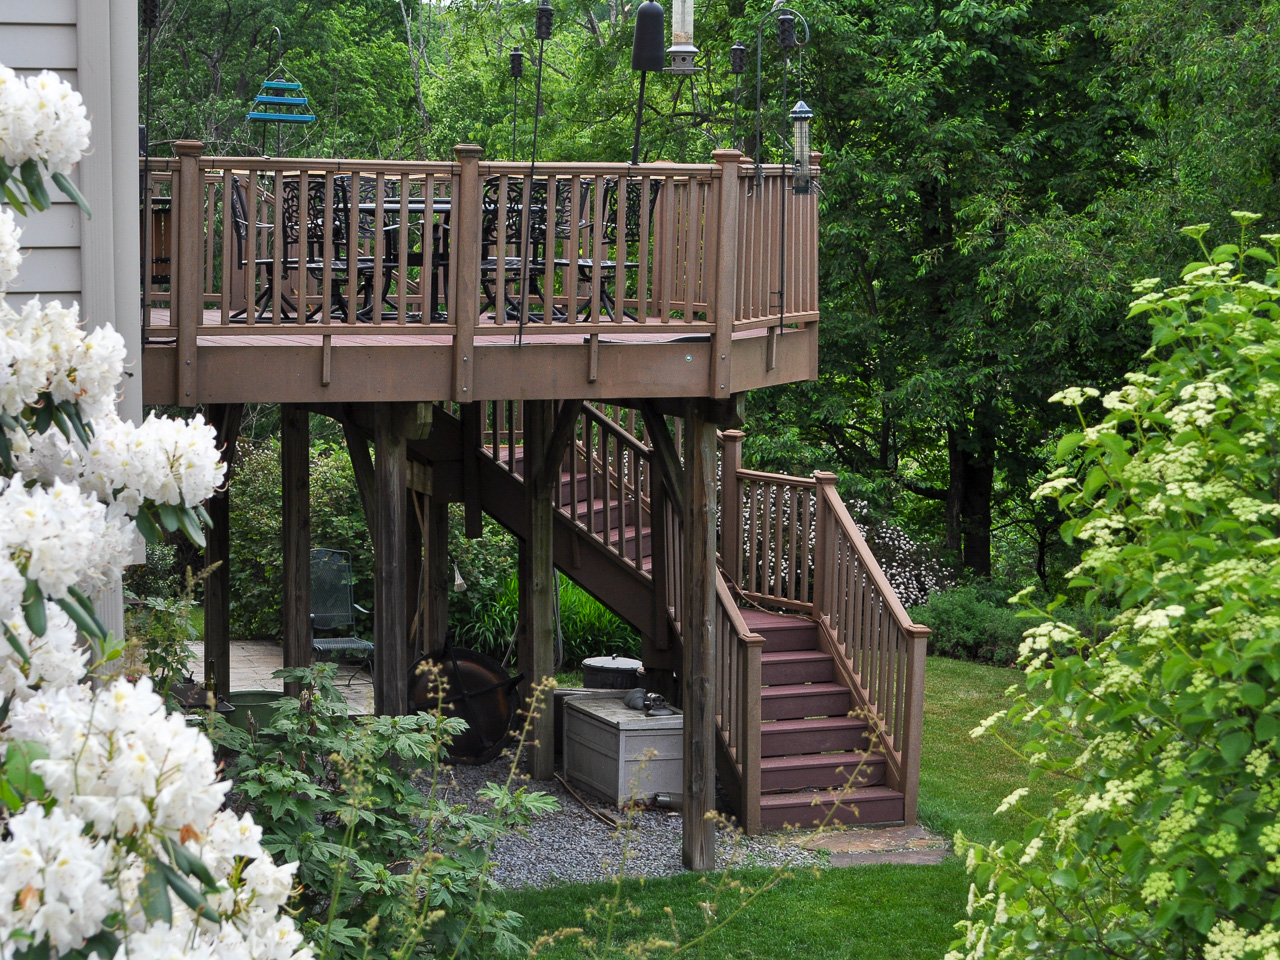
[{"x1": 564, "y1": 698, "x2": 684, "y2": 806}]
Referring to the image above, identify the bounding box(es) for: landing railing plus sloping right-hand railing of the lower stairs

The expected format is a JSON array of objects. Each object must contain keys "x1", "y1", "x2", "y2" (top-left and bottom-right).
[{"x1": 721, "y1": 430, "x2": 929, "y2": 822}]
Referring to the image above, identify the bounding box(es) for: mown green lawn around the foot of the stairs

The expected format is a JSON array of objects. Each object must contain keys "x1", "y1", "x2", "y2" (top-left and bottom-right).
[{"x1": 499, "y1": 658, "x2": 1052, "y2": 960}]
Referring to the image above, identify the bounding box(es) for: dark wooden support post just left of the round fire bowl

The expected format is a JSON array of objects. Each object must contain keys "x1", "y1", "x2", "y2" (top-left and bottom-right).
[{"x1": 374, "y1": 403, "x2": 408, "y2": 717}]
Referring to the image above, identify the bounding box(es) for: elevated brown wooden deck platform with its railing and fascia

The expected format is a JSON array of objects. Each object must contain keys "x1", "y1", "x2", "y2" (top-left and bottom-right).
[{"x1": 142, "y1": 142, "x2": 818, "y2": 406}]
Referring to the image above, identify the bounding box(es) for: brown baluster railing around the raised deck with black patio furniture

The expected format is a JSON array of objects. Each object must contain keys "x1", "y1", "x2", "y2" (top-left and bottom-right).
[{"x1": 143, "y1": 141, "x2": 818, "y2": 401}]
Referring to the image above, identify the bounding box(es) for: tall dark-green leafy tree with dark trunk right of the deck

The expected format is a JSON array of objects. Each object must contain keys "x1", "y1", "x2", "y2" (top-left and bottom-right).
[{"x1": 756, "y1": 0, "x2": 1152, "y2": 576}]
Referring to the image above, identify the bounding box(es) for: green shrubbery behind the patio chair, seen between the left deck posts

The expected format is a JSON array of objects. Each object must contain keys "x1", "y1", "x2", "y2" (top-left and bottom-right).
[{"x1": 230, "y1": 431, "x2": 374, "y2": 647}]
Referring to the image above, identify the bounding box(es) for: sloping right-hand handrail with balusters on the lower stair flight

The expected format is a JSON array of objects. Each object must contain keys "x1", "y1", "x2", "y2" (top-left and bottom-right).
[{"x1": 813, "y1": 471, "x2": 931, "y2": 823}]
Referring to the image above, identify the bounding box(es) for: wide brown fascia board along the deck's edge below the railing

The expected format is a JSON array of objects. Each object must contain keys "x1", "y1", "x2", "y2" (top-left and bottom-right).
[{"x1": 142, "y1": 321, "x2": 818, "y2": 406}]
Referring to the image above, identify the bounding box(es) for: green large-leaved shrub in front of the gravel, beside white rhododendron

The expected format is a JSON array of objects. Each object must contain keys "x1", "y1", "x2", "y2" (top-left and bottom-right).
[{"x1": 211, "y1": 664, "x2": 556, "y2": 960}]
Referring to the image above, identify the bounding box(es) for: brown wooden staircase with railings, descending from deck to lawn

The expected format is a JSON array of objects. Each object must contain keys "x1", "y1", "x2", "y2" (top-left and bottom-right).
[{"x1": 408, "y1": 403, "x2": 928, "y2": 833}]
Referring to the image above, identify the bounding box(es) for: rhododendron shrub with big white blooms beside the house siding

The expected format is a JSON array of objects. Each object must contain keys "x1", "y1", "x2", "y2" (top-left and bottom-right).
[{"x1": 0, "y1": 67, "x2": 308, "y2": 960}]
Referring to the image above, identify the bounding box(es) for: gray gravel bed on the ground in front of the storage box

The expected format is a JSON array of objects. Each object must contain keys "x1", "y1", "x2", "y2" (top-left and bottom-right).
[{"x1": 421, "y1": 759, "x2": 829, "y2": 887}]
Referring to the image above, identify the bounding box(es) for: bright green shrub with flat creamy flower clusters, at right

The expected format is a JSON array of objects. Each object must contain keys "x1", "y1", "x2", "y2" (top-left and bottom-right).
[{"x1": 948, "y1": 214, "x2": 1280, "y2": 960}]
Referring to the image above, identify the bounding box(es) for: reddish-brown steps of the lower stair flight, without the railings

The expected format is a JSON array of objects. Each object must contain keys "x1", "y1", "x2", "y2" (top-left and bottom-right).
[{"x1": 741, "y1": 608, "x2": 904, "y2": 829}]
